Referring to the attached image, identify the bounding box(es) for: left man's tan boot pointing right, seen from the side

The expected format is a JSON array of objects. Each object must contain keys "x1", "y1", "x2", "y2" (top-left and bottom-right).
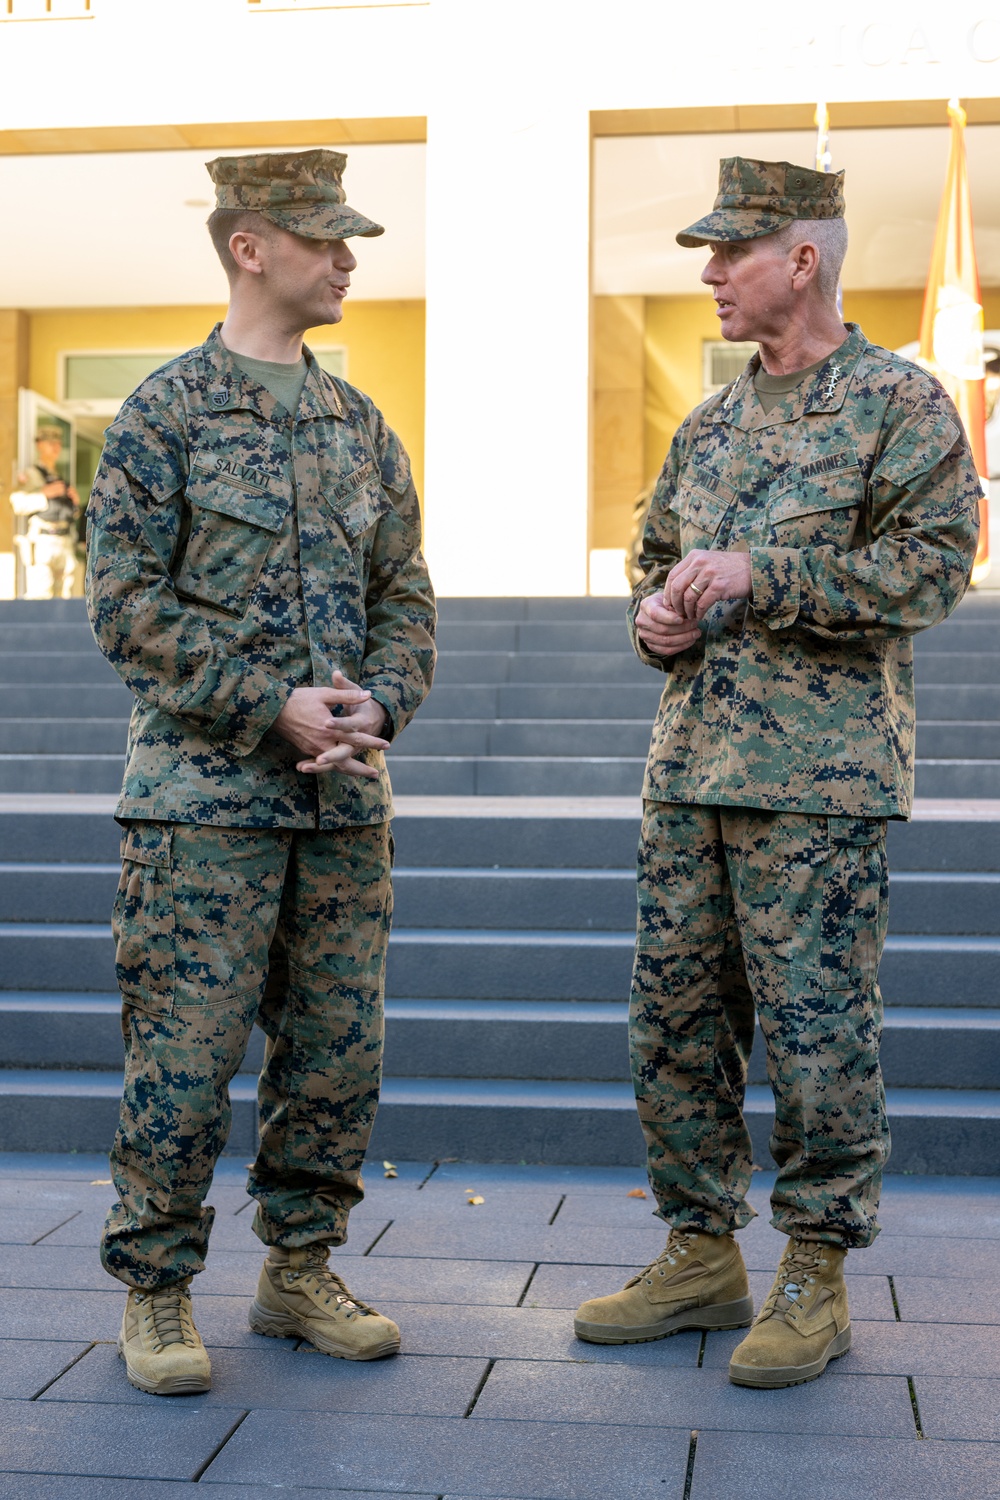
[{"x1": 250, "y1": 1245, "x2": 399, "y2": 1359}]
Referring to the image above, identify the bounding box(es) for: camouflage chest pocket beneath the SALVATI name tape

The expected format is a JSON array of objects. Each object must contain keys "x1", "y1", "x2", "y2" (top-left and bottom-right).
[{"x1": 174, "y1": 470, "x2": 291, "y2": 617}]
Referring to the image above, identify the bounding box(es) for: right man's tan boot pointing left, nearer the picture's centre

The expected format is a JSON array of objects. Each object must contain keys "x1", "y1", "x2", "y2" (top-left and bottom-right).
[{"x1": 573, "y1": 1229, "x2": 754, "y2": 1344}]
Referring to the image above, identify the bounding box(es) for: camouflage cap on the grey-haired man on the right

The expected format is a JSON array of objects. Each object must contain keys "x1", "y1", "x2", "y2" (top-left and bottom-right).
[{"x1": 678, "y1": 156, "x2": 844, "y2": 248}]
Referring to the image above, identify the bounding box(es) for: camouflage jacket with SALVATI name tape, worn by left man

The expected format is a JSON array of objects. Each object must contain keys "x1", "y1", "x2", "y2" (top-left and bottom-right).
[{"x1": 87, "y1": 329, "x2": 435, "y2": 828}]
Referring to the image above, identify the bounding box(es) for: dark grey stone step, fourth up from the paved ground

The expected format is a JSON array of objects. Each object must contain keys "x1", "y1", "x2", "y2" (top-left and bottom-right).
[{"x1": 0, "y1": 861, "x2": 1000, "y2": 930}]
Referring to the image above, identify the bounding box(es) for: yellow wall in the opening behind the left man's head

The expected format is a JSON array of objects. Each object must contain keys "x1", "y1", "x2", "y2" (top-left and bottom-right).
[{"x1": 28, "y1": 302, "x2": 424, "y2": 491}]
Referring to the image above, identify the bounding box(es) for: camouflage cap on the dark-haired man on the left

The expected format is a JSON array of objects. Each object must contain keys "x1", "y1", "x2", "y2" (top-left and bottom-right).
[{"x1": 205, "y1": 150, "x2": 385, "y2": 240}]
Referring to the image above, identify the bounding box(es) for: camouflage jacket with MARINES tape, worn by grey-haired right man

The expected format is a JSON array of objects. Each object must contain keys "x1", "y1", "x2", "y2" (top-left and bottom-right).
[{"x1": 630, "y1": 326, "x2": 982, "y2": 818}]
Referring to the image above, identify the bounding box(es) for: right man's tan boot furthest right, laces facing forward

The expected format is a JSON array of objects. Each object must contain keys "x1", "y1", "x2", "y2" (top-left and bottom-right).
[{"x1": 729, "y1": 1239, "x2": 850, "y2": 1391}]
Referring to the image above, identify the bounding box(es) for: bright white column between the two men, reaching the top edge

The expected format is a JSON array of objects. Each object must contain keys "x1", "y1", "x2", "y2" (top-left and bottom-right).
[{"x1": 424, "y1": 0, "x2": 591, "y2": 596}]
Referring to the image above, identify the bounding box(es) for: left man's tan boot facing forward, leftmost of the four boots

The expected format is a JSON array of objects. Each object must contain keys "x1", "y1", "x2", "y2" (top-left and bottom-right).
[{"x1": 118, "y1": 1281, "x2": 211, "y2": 1397}]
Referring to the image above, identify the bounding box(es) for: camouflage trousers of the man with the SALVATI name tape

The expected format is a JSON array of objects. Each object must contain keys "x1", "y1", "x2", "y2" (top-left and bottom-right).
[{"x1": 100, "y1": 822, "x2": 393, "y2": 1287}]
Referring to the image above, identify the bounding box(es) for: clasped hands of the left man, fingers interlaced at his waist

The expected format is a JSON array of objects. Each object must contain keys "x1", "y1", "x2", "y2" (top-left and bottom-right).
[{"x1": 273, "y1": 672, "x2": 388, "y2": 782}]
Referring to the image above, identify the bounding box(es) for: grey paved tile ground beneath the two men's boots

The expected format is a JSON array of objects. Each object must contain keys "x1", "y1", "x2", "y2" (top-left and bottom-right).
[{"x1": 0, "y1": 1155, "x2": 1000, "y2": 1500}]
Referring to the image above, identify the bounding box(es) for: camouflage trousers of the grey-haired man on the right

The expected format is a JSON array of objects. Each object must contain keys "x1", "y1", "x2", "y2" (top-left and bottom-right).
[{"x1": 630, "y1": 801, "x2": 889, "y2": 1248}]
